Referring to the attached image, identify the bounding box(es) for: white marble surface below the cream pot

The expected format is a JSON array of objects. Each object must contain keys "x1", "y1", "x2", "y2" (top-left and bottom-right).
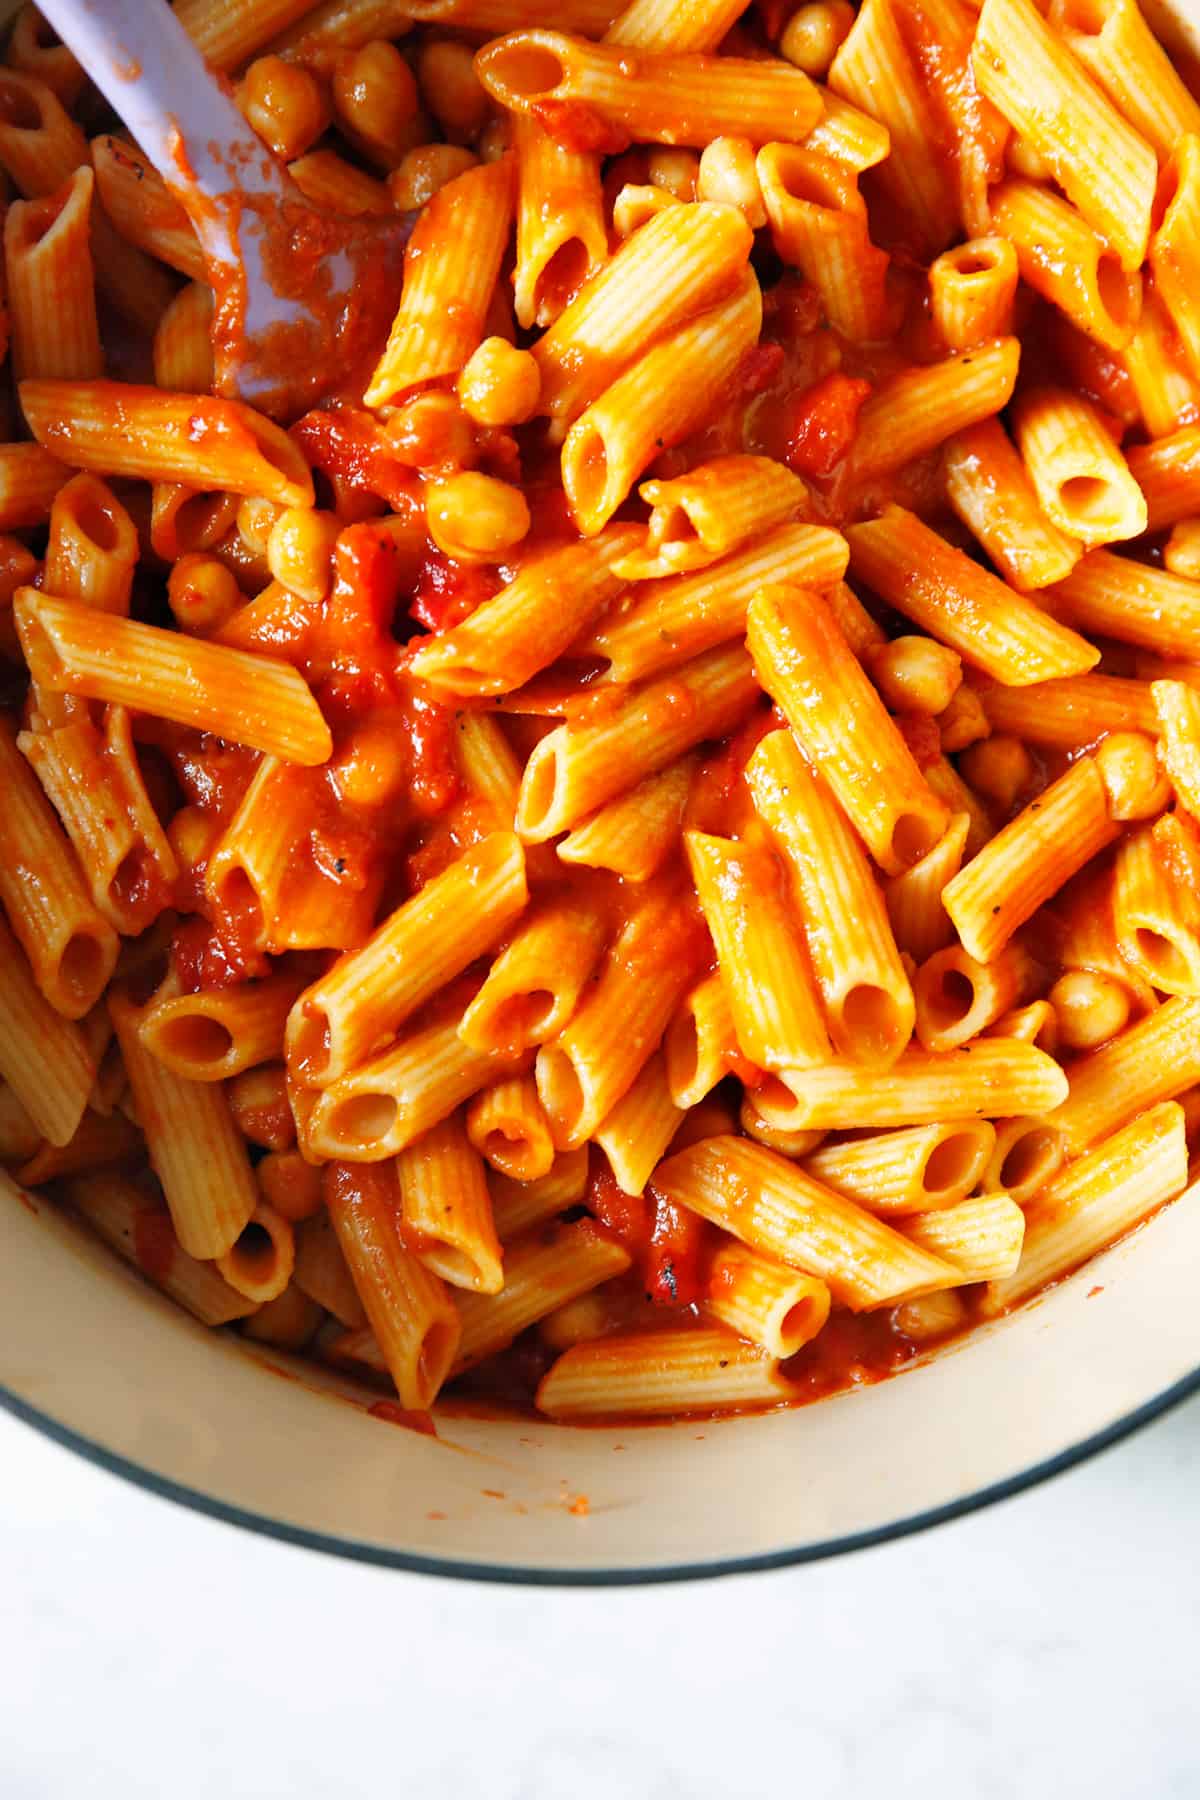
[{"x1": 0, "y1": 1400, "x2": 1200, "y2": 1800}]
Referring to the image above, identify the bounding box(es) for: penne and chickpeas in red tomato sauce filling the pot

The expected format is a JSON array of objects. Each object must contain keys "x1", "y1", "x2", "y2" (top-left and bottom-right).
[{"x1": 0, "y1": 0, "x2": 1200, "y2": 1435}]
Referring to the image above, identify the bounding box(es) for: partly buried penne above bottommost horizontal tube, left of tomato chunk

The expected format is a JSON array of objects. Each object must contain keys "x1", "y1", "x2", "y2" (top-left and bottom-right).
[{"x1": 453, "y1": 1219, "x2": 630, "y2": 1373}]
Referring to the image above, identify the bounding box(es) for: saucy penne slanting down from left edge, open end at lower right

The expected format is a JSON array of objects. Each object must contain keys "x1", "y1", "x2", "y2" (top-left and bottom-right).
[{"x1": 0, "y1": 718, "x2": 119, "y2": 1019}]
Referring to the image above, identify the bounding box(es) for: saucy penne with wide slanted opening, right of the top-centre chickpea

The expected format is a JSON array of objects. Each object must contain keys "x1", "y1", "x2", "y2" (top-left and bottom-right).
[{"x1": 756, "y1": 144, "x2": 889, "y2": 342}]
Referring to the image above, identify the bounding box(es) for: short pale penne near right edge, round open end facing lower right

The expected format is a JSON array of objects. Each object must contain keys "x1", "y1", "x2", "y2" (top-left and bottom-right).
[{"x1": 1013, "y1": 387, "x2": 1148, "y2": 549}]
